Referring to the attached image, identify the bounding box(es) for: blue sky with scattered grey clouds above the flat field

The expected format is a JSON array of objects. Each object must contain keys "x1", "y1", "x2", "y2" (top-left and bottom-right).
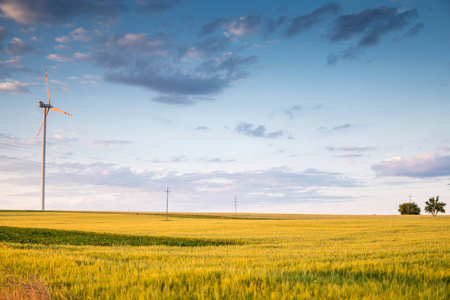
[{"x1": 0, "y1": 0, "x2": 450, "y2": 215}]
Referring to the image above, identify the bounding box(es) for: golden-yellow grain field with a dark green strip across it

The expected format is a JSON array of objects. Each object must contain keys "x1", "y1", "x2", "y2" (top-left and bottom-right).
[{"x1": 0, "y1": 211, "x2": 450, "y2": 299}]
